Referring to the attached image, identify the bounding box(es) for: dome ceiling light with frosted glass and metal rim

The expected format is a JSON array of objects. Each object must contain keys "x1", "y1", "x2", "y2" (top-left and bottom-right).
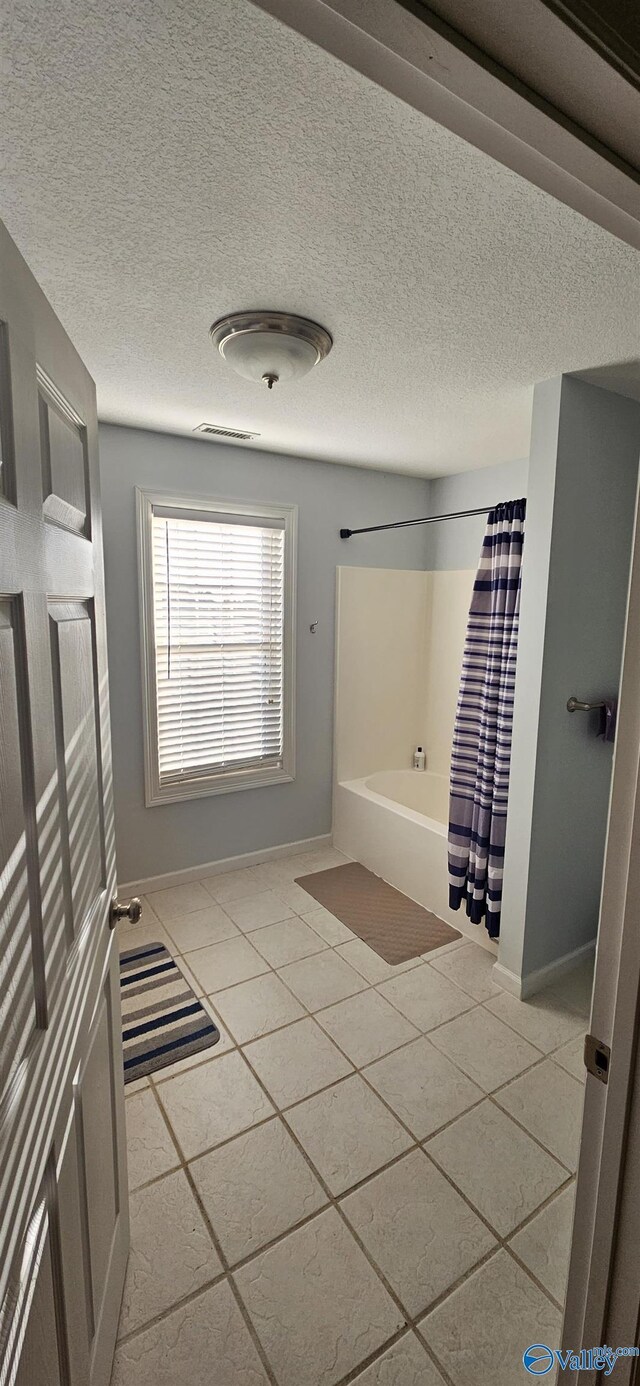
[{"x1": 209, "y1": 310, "x2": 332, "y2": 389}]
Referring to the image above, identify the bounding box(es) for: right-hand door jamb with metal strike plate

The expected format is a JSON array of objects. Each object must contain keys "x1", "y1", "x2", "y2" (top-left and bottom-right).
[{"x1": 562, "y1": 468, "x2": 640, "y2": 1386}]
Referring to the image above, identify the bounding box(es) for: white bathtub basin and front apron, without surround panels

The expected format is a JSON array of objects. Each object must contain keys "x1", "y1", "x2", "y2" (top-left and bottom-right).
[{"x1": 334, "y1": 771, "x2": 497, "y2": 952}]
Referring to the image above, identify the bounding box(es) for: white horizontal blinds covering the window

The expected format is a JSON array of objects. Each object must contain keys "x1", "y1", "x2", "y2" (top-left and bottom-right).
[{"x1": 152, "y1": 507, "x2": 284, "y2": 783}]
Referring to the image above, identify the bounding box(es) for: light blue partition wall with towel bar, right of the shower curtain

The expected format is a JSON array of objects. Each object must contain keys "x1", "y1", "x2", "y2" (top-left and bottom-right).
[{"x1": 497, "y1": 377, "x2": 640, "y2": 995}]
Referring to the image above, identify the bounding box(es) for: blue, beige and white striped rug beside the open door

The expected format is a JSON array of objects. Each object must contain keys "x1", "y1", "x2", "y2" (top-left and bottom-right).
[{"x1": 121, "y1": 944, "x2": 220, "y2": 1082}]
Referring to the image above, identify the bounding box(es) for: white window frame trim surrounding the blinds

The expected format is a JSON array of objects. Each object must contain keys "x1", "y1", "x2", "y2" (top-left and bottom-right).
[{"x1": 136, "y1": 486, "x2": 298, "y2": 808}]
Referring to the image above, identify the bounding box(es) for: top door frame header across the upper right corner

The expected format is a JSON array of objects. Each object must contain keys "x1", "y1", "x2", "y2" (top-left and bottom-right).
[{"x1": 247, "y1": 0, "x2": 640, "y2": 249}]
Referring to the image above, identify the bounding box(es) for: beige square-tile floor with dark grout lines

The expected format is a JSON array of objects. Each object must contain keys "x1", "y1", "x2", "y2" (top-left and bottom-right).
[{"x1": 112, "y1": 850, "x2": 589, "y2": 1386}]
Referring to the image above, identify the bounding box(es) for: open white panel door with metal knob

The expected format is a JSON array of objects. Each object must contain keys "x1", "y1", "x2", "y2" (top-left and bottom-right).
[{"x1": 0, "y1": 223, "x2": 129, "y2": 1386}]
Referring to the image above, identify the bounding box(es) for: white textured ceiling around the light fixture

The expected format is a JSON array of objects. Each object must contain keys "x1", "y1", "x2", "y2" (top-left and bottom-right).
[{"x1": 0, "y1": 0, "x2": 640, "y2": 475}]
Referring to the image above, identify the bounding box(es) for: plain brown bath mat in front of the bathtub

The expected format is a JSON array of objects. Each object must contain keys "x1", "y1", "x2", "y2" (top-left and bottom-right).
[{"x1": 296, "y1": 862, "x2": 460, "y2": 965}]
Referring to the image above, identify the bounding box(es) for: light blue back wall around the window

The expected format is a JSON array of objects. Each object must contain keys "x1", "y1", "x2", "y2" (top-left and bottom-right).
[{"x1": 100, "y1": 426, "x2": 429, "y2": 881}]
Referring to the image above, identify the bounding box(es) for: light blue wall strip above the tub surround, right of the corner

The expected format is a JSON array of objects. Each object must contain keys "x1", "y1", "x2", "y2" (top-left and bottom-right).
[{"x1": 427, "y1": 457, "x2": 529, "y2": 570}]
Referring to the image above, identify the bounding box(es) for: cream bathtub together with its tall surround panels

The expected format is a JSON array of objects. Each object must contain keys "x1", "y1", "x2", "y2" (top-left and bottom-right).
[{"x1": 334, "y1": 568, "x2": 495, "y2": 951}]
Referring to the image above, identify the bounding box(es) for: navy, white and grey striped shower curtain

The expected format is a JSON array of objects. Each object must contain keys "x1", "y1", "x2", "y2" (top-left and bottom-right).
[{"x1": 449, "y1": 500, "x2": 526, "y2": 938}]
